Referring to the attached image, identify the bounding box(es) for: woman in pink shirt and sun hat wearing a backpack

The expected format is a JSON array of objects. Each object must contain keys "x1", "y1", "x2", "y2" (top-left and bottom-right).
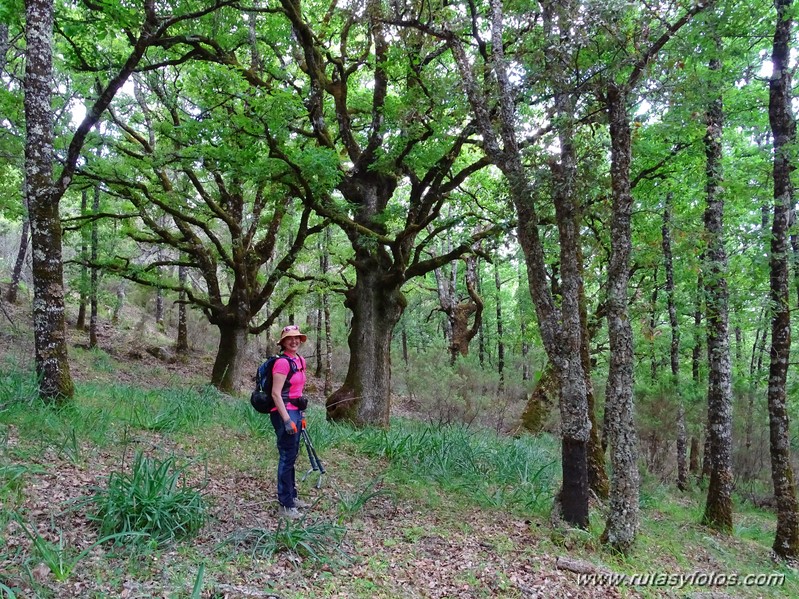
[{"x1": 270, "y1": 324, "x2": 309, "y2": 519}]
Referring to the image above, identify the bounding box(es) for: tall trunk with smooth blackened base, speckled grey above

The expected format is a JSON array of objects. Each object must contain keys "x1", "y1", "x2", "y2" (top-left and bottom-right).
[{"x1": 544, "y1": 2, "x2": 595, "y2": 527}]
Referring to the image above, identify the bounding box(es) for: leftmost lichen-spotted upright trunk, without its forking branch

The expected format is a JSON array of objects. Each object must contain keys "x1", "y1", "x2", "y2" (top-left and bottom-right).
[{"x1": 24, "y1": 0, "x2": 75, "y2": 400}]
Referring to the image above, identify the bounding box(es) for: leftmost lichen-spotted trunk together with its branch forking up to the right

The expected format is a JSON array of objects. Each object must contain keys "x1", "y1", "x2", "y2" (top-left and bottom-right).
[{"x1": 23, "y1": 0, "x2": 176, "y2": 399}]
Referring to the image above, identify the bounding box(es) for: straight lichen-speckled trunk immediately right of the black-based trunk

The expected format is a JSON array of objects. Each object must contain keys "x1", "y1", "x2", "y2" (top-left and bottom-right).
[{"x1": 603, "y1": 84, "x2": 639, "y2": 553}]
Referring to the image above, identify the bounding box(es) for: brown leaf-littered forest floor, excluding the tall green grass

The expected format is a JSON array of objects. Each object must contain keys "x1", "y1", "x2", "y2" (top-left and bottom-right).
[{"x1": 0, "y1": 288, "x2": 799, "y2": 599}]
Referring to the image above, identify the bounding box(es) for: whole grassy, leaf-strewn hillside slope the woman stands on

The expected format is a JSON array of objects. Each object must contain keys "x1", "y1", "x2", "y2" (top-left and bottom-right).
[{"x1": 0, "y1": 288, "x2": 799, "y2": 598}]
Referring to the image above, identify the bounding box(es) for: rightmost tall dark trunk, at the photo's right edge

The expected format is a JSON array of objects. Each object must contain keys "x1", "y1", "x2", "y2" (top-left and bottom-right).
[{"x1": 768, "y1": 0, "x2": 799, "y2": 559}]
